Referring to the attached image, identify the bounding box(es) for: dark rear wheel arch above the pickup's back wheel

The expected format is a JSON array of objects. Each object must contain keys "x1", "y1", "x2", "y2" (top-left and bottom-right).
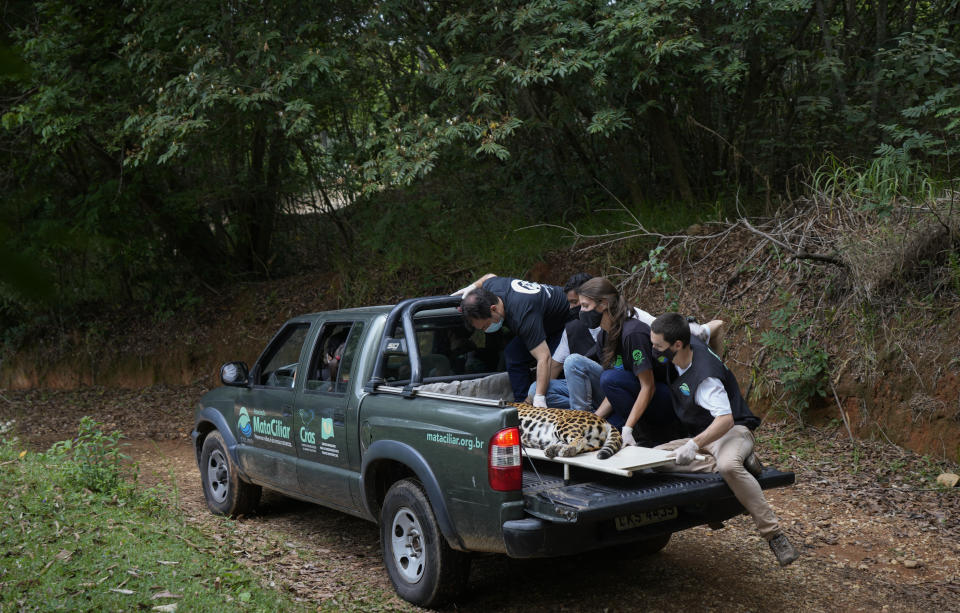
[{"x1": 360, "y1": 441, "x2": 465, "y2": 551}]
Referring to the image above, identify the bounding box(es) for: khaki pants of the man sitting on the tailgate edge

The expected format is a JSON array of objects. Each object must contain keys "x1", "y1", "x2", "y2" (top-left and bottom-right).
[{"x1": 656, "y1": 426, "x2": 780, "y2": 540}]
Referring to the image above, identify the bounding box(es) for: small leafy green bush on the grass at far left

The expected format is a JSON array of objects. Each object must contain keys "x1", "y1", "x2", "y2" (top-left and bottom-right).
[{"x1": 50, "y1": 416, "x2": 137, "y2": 495}]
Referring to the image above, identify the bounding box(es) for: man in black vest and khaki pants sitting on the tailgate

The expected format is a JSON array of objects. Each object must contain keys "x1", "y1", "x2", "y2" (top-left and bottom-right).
[{"x1": 650, "y1": 313, "x2": 800, "y2": 566}]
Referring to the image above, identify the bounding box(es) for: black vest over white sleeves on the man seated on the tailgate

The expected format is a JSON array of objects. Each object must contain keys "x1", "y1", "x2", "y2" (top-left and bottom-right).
[{"x1": 670, "y1": 338, "x2": 760, "y2": 437}]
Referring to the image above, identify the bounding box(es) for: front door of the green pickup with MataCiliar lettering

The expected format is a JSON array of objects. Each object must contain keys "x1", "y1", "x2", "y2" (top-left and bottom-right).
[{"x1": 235, "y1": 323, "x2": 310, "y2": 494}]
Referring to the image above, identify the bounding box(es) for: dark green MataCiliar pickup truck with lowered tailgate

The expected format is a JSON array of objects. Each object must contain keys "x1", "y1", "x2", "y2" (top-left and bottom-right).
[{"x1": 192, "y1": 296, "x2": 794, "y2": 607}]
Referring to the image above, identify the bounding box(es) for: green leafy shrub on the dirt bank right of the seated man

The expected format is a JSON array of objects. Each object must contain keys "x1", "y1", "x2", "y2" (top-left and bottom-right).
[{"x1": 760, "y1": 292, "x2": 829, "y2": 423}]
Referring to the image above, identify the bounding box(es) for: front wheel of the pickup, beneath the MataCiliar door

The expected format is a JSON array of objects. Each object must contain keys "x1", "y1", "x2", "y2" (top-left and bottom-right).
[{"x1": 200, "y1": 430, "x2": 262, "y2": 517}]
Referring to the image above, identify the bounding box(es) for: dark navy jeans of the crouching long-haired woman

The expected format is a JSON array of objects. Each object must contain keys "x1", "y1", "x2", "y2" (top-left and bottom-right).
[{"x1": 600, "y1": 368, "x2": 683, "y2": 445}]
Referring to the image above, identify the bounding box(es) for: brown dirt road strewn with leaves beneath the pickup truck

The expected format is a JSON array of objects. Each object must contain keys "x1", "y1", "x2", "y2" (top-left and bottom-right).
[{"x1": 0, "y1": 389, "x2": 960, "y2": 612}]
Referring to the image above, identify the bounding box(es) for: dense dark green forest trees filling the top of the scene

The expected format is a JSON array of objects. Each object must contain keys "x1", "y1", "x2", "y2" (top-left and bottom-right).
[{"x1": 0, "y1": 0, "x2": 960, "y2": 332}]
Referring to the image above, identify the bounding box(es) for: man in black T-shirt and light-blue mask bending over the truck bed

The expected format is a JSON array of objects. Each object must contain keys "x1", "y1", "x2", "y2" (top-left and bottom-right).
[{"x1": 455, "y1": 274, "x2": 573, "y2": 407}]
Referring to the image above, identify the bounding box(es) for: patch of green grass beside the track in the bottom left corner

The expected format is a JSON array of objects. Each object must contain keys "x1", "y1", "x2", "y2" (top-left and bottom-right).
[{"x1": 0, "y1": 418, "x2": 306, "y2": 611}]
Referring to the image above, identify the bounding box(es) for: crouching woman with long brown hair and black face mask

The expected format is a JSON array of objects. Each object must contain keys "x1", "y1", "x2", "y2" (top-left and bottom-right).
[{"x1": 579, "y1": 277, "x2": 680, "y2": 446}]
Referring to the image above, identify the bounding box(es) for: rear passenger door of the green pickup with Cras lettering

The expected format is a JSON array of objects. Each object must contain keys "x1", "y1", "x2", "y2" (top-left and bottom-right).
[{"x1": 294, "y1": 321, "x2": 364, "y2": 509}]
